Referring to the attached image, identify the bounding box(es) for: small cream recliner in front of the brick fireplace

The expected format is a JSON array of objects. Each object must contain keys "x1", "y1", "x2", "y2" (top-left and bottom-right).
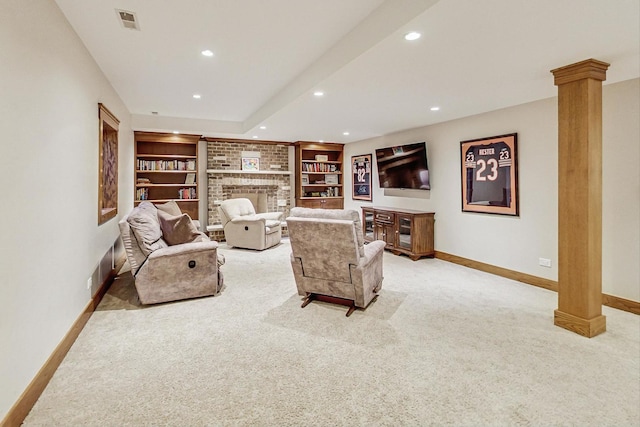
[{"x1": 218, "y1": 198, "x2": 282, "y2": 251}]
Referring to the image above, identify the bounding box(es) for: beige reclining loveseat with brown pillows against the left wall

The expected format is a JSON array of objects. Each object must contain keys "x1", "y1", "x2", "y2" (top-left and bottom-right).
[{"x1": 118, "y1": 202, "x2": 224, "y2": 304}]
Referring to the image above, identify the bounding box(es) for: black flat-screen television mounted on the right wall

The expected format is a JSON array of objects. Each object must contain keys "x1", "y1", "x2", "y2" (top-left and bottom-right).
[{"x1": 376, "y1": 142, "x2": 431, "y2": 190}]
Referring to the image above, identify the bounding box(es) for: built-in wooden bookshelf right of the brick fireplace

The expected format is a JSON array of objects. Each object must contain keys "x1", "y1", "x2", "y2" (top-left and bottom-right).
[{"x1": 295, "y1": 141, "x2": 344, "y2": 209}]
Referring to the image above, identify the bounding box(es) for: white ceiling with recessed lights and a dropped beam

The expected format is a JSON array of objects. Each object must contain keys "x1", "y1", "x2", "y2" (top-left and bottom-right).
[{"x1": 56, "y1": 0, "x2": 640, "y2": 142}]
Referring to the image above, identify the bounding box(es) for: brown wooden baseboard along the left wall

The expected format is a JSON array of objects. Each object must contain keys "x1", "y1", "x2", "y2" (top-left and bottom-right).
[{"x1": 0, "y1": 256, "x2": 125, "y2": 427}]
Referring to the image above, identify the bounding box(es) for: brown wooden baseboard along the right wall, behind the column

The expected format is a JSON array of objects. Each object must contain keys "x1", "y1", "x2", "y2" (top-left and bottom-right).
[{"x1": 435, "y1": 251, "x2": 640, "y2": 315}]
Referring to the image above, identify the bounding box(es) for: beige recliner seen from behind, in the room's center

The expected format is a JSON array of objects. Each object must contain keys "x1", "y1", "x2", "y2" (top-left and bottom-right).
[{"x1": 287, "y1": 208, "x2": 385, "y2": 317}]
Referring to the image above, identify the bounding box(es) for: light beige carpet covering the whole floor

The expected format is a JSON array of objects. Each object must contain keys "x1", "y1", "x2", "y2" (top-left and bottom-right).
[{"x1": 25, "y1": 241, "x2": 640, "y2": 426}]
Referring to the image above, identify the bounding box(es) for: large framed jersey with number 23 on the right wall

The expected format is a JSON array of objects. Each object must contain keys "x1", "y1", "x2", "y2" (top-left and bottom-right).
[{"x1": 460, "y1": 133, "x2": 519, "y2": 216}]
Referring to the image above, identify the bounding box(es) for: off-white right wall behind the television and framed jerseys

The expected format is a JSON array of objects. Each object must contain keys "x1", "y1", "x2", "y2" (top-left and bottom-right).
[{"x1": 345, "y1": 79, "x2": 640, "y2": 301}]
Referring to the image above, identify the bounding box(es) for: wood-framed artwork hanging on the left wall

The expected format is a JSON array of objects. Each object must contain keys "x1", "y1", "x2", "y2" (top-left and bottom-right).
[{"x1": 98, "y1": 104, "x2": 120, "y2": 225}]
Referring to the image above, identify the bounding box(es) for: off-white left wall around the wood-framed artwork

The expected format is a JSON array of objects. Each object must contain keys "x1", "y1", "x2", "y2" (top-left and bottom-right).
[{"x1": 0, "y1": 0, "x2": 133, "y2": 419}]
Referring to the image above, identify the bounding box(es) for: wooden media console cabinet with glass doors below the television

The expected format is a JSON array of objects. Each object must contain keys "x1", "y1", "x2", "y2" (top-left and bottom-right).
[{"x1": 362, "y1": 207, "x2": 435, "y2": 261}]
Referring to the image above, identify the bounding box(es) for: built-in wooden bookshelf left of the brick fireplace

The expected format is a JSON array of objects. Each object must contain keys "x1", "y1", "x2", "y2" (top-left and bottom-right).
[{"x1": 134, "y1": 132, "x2": 200, "y2": 219}]
